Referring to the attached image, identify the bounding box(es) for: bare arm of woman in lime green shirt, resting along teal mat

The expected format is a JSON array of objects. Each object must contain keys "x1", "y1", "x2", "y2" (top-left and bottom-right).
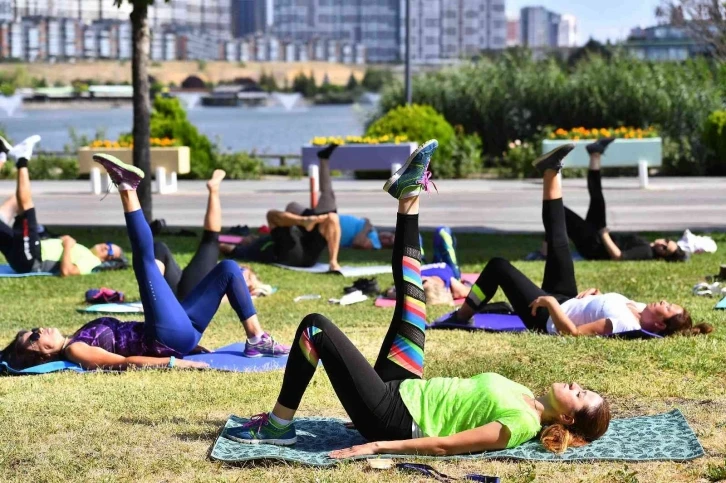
[{"x1": 330, "y1": 422, "x2": 510, "y2": 458}]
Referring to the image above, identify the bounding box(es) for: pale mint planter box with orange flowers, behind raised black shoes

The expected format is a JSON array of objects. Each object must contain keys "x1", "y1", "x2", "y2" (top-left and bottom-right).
[{"x1": 542, "y1": 138, "x2": 663, "y2": 168}]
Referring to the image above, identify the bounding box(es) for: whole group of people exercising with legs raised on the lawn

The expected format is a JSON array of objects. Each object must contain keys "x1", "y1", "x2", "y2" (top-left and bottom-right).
[{"x1": 0, "y1": 134, "x2": 712, "y2": 458}]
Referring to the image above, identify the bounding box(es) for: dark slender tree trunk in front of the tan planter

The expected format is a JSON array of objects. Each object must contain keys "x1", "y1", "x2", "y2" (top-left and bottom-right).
[{"x1": 131, "y1": 2, "x2": 152, "y2": 221}]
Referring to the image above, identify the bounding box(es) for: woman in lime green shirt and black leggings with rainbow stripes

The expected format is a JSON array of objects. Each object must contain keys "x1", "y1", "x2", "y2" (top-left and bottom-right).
[{"x1": 223, "y1": 140, "x2": 610, "y2": 458}]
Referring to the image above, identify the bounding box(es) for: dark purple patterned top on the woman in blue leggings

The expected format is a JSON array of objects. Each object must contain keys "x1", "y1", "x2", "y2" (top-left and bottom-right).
[{"x1": 68, "y1": 317, "x2": 182, "y2": 357}]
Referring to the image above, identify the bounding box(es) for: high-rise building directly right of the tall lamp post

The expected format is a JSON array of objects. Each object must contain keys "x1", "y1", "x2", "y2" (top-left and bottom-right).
[{"x1": 400, "y1": 0, "x2": 507, "y2": 62}]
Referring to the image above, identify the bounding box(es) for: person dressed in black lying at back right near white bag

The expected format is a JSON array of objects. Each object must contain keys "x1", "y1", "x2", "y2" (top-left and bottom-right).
[{"x1": 565, "y1": 138, "x2": 688, "y2": 262}]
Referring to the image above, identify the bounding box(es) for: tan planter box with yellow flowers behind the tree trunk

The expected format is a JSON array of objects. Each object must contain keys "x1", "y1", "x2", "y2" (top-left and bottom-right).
[{"x1": 78, "y1": 146, "x2": 191, "y2": 178}]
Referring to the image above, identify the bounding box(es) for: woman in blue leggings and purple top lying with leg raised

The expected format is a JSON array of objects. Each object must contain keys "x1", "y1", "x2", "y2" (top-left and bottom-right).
[{"x1": 2, "y1": 154, "x2": 289, "y2": 369}]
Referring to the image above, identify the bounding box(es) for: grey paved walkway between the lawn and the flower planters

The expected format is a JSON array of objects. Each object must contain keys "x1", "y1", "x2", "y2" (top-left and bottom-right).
[{"x1": 0, "y1": 178, "x2": 726, "y2": 232}]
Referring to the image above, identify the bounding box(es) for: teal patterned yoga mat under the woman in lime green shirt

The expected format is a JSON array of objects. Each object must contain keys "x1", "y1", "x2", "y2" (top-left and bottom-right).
[{"x1": 210, "y1": 409, "x2": 704, "y2": 466}]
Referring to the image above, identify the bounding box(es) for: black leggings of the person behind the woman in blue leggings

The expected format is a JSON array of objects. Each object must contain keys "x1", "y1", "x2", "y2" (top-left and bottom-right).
[{"x1": 154, "y1": 230, "x2": 219, "y2": 300}]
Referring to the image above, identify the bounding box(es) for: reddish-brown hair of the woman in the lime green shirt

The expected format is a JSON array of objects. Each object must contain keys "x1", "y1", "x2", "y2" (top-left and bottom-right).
[{"x1": 540, "y1": 398, "x2": 610, "y2": 453}]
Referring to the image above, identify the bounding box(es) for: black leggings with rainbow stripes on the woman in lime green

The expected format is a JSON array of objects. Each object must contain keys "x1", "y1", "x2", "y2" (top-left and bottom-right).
[{"x1": 278, "y1": 214, "x2": 426, "y2": 441}]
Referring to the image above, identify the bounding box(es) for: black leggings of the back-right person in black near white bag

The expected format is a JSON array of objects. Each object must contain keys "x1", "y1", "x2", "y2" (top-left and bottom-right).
[{"x1": 565, "y1": 169, "x2": 610, "y2": 260}]
